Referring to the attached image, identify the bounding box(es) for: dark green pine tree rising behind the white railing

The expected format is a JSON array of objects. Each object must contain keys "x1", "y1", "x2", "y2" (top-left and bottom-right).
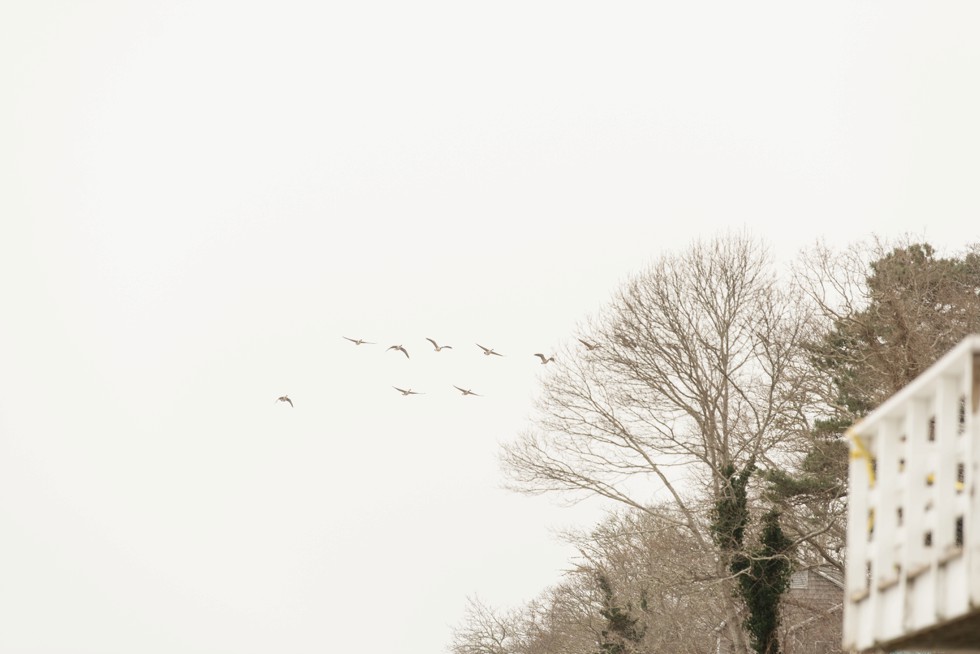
[{"x1": 763, "y1": 241, "x2": 980, "y2": 567}]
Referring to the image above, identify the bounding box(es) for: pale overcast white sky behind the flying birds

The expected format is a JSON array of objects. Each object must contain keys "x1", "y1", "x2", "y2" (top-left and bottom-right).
[{"x1": 0, "y1": 0, "x2": 980, "y2": 654}]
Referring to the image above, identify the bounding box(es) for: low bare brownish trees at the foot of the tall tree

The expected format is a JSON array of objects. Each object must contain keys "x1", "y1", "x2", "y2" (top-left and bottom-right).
[{"x1": 450, "y1": 508, "x2": 725, "y2": 654}]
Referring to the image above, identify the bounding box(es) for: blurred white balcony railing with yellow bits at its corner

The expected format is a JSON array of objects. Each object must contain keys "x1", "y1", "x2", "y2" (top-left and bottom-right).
[{"x1": 844, "y1": 335, "x2": 980, "y2": 652}]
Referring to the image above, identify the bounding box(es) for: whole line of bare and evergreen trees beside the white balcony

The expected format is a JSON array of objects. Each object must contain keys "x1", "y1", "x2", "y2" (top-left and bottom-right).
[{"x1": 449, "y1": 233, "x2": 980, "y2": 654}]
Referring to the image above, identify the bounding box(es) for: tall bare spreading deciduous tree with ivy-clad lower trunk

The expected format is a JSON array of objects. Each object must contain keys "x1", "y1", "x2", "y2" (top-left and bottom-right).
[{"x1": 503, "y1": 235, "x2": 811, "y2": 652}]
